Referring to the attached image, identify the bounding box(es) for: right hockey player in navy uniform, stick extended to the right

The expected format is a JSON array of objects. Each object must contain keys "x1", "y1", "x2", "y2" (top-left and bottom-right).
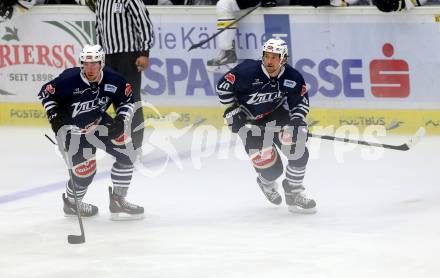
[{"x1": 217, "y1": 39, "x2": 316, "y2": 213}]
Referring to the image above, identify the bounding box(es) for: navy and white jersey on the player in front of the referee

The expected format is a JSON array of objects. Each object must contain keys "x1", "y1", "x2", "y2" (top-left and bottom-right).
[{"x1": 38, "y1": 67, "x2": 134, "y2": 128}]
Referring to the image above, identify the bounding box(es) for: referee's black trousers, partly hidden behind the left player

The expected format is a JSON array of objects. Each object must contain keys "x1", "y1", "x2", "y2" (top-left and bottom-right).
[{"x1": 105, "y1": 52, "x2": 145, "y2": 150}]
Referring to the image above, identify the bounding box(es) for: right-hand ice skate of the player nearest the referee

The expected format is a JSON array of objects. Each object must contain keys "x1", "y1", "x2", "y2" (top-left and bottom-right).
[{"x1": 108, "y1": 187, "x2": 144, "y2": 221}]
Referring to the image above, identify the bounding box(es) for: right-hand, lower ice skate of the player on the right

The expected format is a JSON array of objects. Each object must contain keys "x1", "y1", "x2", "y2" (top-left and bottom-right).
[{"x1": 283, "y1": 180, "x2": 316, "y2": 214}]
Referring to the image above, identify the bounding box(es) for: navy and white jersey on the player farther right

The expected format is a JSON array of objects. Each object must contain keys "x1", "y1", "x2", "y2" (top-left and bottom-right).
[{"x1": 216, "y1": 60, "x2": 309, "y2": 120}]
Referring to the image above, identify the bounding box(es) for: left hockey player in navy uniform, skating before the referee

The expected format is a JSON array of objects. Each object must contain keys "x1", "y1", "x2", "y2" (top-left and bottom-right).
[{"x1": 38, "y1": 45, "x2": 144, "y2": 220}]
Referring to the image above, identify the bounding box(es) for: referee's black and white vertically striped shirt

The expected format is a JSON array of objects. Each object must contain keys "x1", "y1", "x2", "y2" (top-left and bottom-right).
[{"x1": 96, "y1": 0, "x2": 153, "y2": 56}]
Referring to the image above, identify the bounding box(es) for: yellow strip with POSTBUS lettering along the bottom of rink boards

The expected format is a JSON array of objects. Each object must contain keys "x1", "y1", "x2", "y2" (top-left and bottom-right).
[{"x1": 0, "y1": 103, "x2": 440, "y2": 134}]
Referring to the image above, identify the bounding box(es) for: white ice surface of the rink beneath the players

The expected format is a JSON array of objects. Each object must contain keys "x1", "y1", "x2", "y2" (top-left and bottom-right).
[{"x1": 0, "y1": 127, "x2": 440, "y2": 278}]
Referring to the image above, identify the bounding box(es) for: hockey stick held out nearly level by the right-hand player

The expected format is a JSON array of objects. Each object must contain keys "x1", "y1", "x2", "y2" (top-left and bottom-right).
[{"x1": 246, "y1": 126, "x2": 426, "y2": 151}]
